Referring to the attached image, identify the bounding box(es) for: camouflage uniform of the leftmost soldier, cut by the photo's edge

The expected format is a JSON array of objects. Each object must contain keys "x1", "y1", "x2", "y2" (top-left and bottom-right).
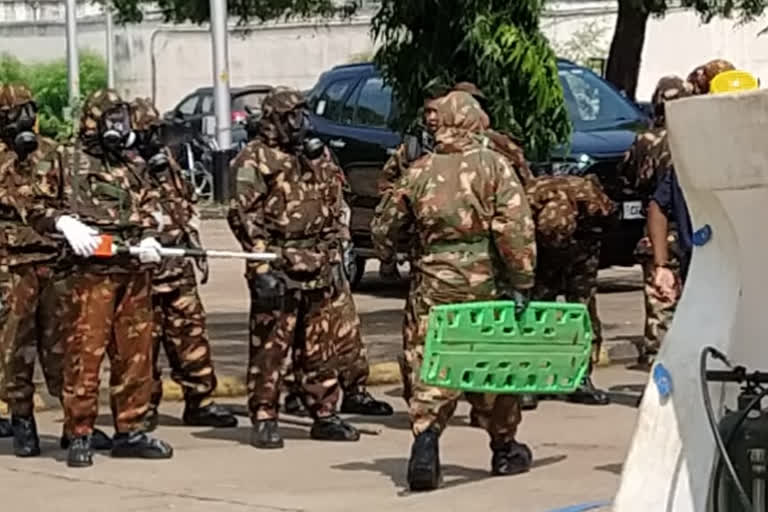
[{"x1": 0, "y1": 86, "x2": 62, "y2": 417}]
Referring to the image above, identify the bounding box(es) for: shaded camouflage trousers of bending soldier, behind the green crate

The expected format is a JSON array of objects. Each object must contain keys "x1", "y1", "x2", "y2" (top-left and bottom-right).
[{"x1": 532, "y1": 239, "x2": 603, "y2": 371}]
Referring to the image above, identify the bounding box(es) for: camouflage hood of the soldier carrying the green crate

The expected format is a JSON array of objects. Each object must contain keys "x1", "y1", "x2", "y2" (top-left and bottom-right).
[{"x1": 435, "y1": 91, "x2": 490, "y2": 153}]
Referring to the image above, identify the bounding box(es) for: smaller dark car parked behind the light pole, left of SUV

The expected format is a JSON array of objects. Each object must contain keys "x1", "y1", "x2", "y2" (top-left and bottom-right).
[{"x1": 164, "y1": 85, "x2": 272, "y2": 145}]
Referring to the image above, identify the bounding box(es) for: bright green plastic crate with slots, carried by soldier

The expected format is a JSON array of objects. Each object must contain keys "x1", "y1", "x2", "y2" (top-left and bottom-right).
[{"x1": 421, "y1": 301, "x2": 593, "y2": 394}]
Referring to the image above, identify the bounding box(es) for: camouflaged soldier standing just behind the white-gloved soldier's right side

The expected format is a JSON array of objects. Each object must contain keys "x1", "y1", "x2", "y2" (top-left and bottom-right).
[{"x1": 131, "y1": 98, "x2": 237, "y2": 431}]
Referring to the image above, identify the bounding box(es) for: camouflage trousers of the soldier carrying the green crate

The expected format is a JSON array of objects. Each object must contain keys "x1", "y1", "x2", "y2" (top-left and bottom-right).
[{"x1": 401, "y1": 288, "x2": 522, "y2": 442}]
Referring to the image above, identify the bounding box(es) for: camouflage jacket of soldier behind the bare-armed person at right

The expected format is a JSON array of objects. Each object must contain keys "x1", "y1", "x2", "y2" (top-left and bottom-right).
[{"x1": 619, "y1": 127, "x2": 672, "y2": 209}]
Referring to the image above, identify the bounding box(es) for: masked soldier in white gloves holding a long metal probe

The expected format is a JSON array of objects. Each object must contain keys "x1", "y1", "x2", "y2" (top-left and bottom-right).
[{"x1": 32, "y1": 89, "x2": 173, "y2": 467}]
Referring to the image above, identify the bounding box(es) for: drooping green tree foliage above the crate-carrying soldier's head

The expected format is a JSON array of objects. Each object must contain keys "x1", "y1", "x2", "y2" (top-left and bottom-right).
[{"x1": 373, "y1": 0, "x2": 570, "y2": 158}]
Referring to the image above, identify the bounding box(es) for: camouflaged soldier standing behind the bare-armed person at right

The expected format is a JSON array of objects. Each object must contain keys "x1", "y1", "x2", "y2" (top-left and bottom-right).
[{"x1": 620, "y1": 75, "x2": 698, "y2": 365}]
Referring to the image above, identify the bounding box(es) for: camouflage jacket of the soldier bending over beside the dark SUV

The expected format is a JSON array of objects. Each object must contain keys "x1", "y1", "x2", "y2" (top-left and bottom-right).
[{"x1": 526, "y1": 174, "x2": 616, "y2": 249}]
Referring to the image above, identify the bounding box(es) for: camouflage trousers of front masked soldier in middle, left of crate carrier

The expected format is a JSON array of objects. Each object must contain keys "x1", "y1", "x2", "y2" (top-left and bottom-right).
[{"x1": 248, "y1": 288, "x2": 343, "y2": 421}]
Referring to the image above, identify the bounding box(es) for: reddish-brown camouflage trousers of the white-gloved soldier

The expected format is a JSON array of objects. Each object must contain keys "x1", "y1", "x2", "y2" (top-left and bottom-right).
[{"x1": 63, "y1": 272, "x2": 152, "y2": 436}]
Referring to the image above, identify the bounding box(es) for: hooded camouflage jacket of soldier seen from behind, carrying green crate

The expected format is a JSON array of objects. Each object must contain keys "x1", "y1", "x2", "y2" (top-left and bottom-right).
[{"x1": 371, "y1": 92, "x2": 536, "y2": 302}]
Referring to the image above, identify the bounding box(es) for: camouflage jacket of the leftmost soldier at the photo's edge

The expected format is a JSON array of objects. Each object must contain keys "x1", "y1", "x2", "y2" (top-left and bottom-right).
[{"x1": 0, "y1": 138, "x2": 59, "y2": 267}]
